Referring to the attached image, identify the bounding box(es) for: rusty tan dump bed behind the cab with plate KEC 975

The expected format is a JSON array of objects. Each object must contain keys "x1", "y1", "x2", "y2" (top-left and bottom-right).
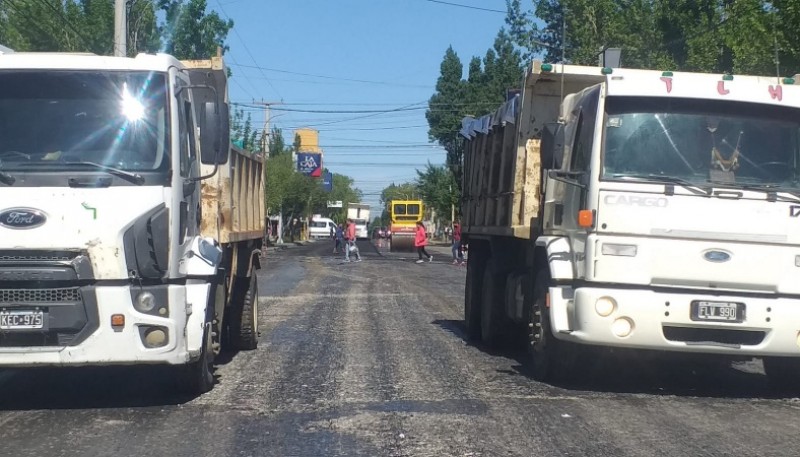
[{"x1": 182, "y1": 55, "x2": 266, "y2": 244}]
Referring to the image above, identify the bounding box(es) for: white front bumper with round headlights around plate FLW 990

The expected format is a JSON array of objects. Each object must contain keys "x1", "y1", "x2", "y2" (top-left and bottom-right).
[{"x1": 550, "y1": 287, "x2": 800, "y2": 356}]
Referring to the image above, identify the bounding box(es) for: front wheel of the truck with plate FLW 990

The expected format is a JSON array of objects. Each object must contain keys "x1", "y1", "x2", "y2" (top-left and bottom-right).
[{"x1": 528, "y1": 269, "x2": 572, "y2": 381}]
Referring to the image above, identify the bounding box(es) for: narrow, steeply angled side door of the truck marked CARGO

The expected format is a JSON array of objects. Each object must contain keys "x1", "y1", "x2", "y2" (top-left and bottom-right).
[{"x1": 562, "y1": 85, "x2": 601, "y2": 279}]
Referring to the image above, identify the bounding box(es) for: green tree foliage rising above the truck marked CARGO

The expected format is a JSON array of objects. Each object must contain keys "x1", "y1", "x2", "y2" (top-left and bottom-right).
[{"x1": 506, "y1": 0, "x2": 800, "y2": 75}]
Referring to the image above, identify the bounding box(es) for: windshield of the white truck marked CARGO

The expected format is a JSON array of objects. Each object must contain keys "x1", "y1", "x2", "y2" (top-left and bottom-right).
[{"x1": 603, "y1": 97, "x2": 800, "y2": 189}]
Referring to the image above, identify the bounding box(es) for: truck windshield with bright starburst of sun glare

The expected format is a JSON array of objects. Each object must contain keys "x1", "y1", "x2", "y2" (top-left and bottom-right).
[{"x1": 0, "y1": 70, "x2": 169, "y2": 172}]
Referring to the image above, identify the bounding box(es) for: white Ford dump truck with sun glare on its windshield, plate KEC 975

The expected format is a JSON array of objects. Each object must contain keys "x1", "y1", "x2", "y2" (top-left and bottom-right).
[{"x1": 0, "y1": 49, "x2": 265, "y2": 392}]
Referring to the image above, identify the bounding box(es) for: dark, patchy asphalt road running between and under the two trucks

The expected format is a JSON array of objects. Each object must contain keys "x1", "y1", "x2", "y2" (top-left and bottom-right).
[{"x1": 0, "y1": 242, "x2": 800, "y2": 457}]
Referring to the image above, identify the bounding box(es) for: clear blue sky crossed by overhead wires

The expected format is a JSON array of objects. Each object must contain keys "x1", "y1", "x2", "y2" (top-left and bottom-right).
[{"x1": 208, "y1": 0, "x2": 505, "y2": 207}]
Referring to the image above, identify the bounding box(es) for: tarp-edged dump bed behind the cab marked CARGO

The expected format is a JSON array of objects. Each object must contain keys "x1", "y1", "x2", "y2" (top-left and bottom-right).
[{"x1": 461, "y1": 61, "x2": 606, "y2": 238}]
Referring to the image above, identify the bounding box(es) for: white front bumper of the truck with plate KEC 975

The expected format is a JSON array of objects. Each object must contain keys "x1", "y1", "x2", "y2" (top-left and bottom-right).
[{"x1": 0, "y1": 285, "x2": 192, "y2": 366}]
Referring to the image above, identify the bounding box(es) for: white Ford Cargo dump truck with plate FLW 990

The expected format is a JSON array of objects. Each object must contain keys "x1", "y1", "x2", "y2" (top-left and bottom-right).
[{"x1": 461, "y1": 62, "x2": 800, "y2": 385}]
